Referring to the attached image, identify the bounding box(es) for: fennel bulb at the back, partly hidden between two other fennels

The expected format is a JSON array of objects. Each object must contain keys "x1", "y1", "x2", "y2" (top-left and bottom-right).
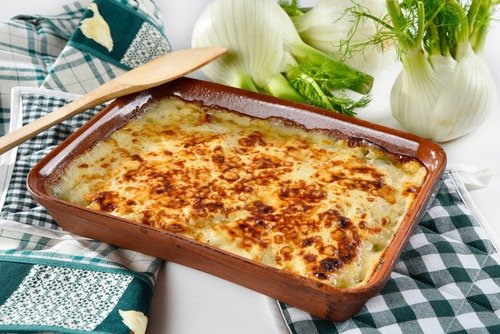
[{"x1": 288, "y1": 0, "x2": 395, "y2": 75}]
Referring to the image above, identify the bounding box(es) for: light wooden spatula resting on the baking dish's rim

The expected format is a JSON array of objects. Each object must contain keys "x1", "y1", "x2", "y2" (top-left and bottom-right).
[{"x1": 0, "y1": 47, "x2": 226, "y2": 154}]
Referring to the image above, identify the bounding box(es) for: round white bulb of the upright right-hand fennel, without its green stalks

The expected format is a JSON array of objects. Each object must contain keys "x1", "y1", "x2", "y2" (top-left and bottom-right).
[{"x1": 391, "y1": 45, "x2": 497, "y2": 142}]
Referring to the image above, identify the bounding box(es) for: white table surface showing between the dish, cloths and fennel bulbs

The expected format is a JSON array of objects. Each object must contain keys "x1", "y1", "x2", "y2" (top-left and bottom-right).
[{"x1": 0, "y1": 0, "x2": 500, "y2": 334}]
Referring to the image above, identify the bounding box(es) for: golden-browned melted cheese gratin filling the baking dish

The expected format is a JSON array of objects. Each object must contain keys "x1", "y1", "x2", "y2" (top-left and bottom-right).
[{"x1": 53, "y1": 97, "x2": 427, "y2": 287}]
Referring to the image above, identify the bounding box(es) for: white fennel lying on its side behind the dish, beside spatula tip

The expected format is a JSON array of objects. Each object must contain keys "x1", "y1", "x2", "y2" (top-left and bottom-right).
[{"x1": 192, "y1": 0, "x2": 373, "y2": 115}]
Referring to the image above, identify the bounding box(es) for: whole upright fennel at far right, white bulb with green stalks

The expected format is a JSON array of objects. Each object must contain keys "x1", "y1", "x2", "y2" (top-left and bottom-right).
[{"x1": 387, "y1": 0, "x2": 497, "y2": 142}]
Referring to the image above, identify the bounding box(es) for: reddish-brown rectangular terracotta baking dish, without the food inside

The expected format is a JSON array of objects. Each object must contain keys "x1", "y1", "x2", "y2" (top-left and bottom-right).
[{"x1": 28, "y1": 78, "x2": 446, "y2": 321}]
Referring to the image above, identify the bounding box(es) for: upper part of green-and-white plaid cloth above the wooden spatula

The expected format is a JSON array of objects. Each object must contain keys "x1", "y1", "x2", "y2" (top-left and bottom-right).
[{"x1": 0, "y1": 0, "x2": 170, "y2": 135}]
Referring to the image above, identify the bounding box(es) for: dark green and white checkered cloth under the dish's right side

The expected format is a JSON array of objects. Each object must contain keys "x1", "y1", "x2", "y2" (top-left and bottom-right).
[{"x1": 272, "y1": 168, "x2": 500, "y2": 334}]
